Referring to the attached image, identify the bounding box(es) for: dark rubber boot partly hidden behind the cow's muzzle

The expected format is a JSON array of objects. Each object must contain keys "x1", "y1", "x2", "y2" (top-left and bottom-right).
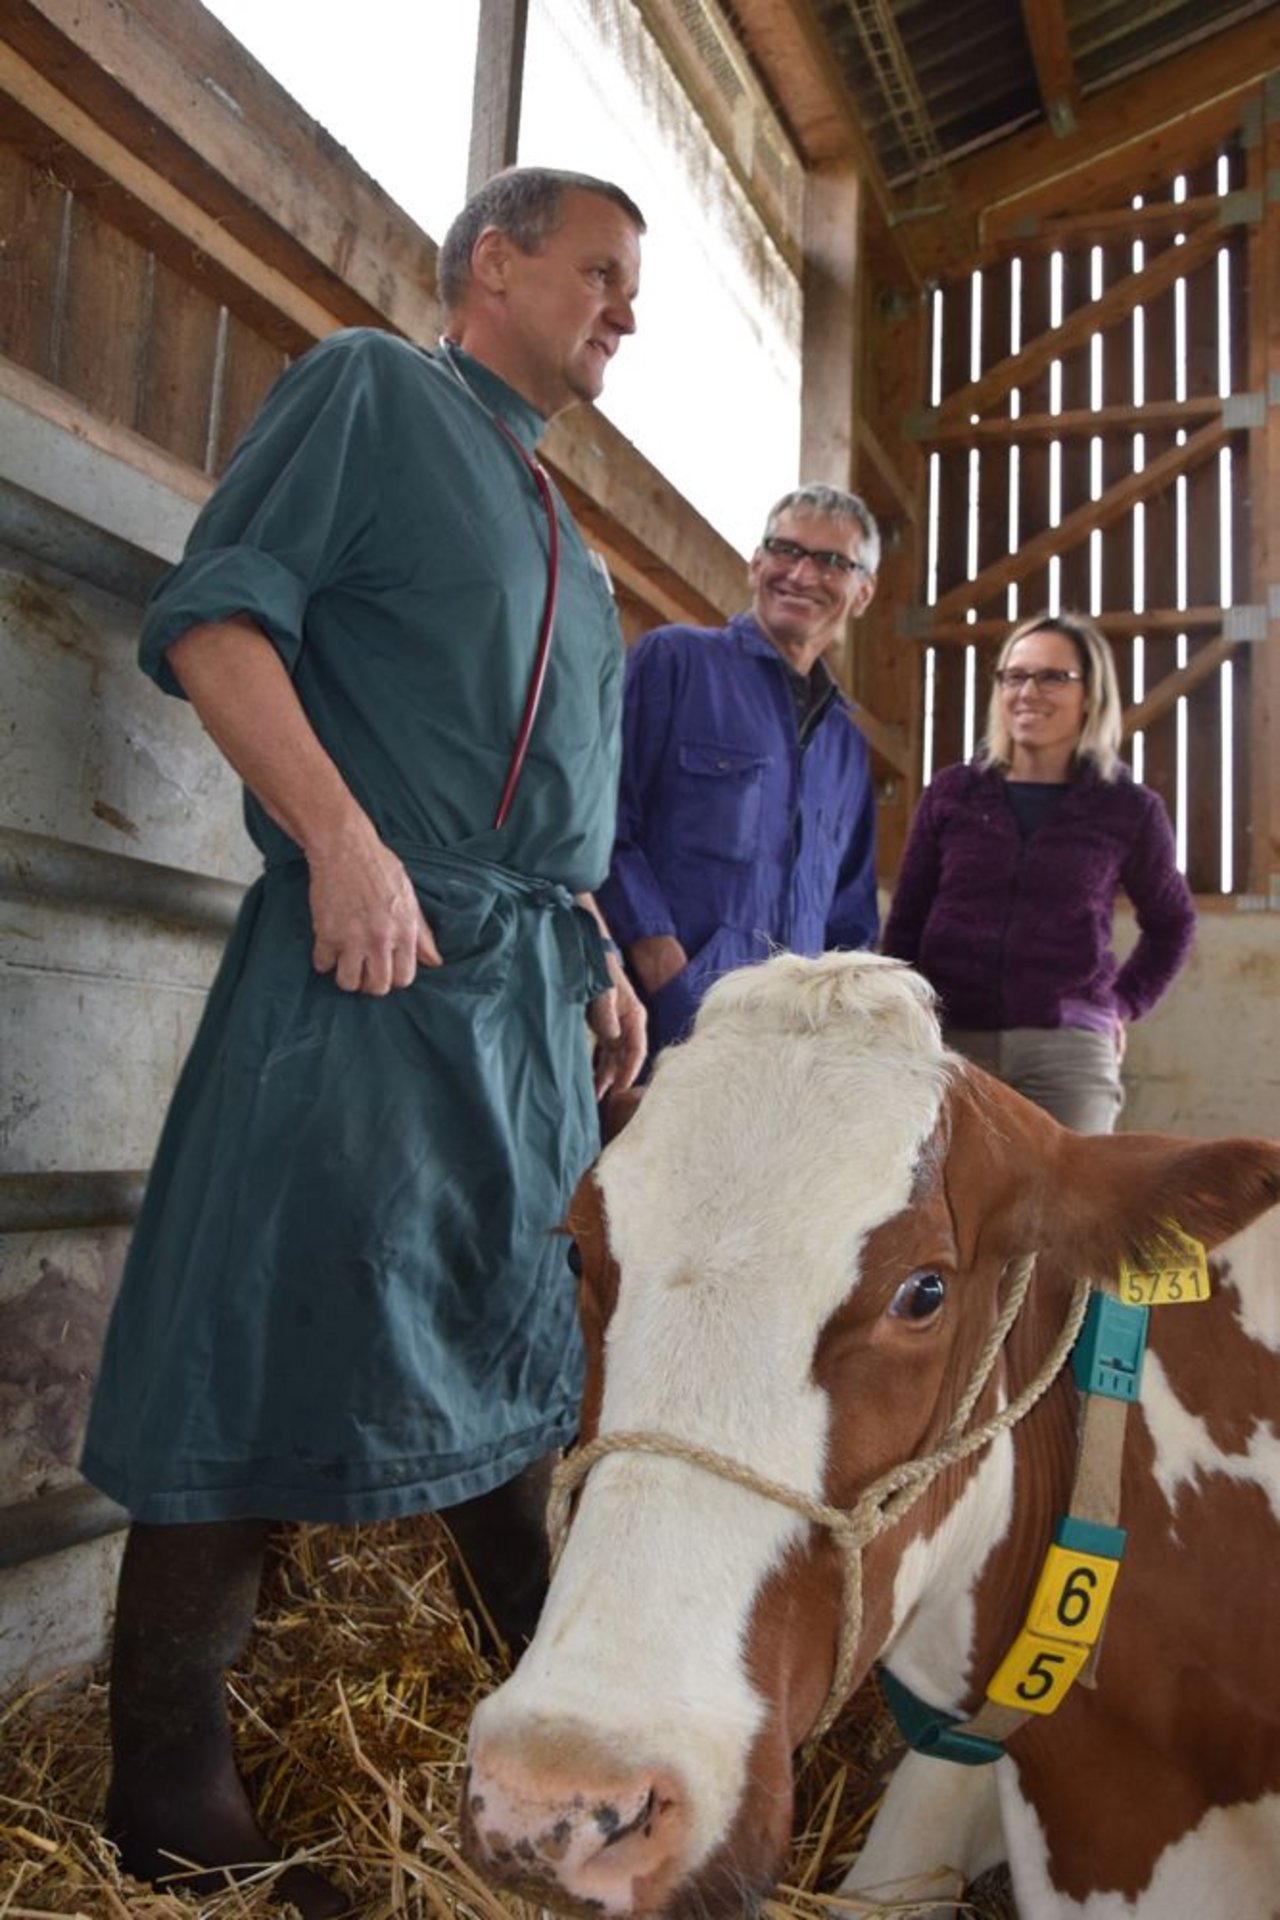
[{"x1": 441, "y1": 1453, "x2": 555, "y2": 1665}]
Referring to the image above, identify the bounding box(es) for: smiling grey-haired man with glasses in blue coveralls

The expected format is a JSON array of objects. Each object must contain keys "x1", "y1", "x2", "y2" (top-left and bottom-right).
[{"x1": 599, "y1": 484, "x2": 881, "y2": 1054}]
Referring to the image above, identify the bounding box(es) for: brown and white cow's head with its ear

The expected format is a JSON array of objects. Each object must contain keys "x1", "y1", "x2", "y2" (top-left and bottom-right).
[{"x1": 464, "y1": 954, "x2": 1280, "y2": 1920}]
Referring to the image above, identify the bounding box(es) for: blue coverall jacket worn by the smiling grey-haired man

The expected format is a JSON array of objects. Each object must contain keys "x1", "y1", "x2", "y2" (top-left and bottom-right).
[{"x1": 599, "y1": 614, "x2": 877, "y2": 1052}]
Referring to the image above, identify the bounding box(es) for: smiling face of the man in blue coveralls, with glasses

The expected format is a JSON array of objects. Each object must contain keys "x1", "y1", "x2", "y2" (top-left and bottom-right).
[{"x1": 750, "y1": 513, "x2": 875, "y2": 674}]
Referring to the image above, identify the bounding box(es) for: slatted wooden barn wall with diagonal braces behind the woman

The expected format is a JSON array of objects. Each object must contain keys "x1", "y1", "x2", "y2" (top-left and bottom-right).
[{"x1": 908, "y1": 142, "x2": 1268, "y2": 895}]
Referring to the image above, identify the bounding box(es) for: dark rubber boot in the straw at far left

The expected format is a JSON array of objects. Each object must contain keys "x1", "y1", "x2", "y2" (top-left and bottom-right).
[{"x1": 104, "y1": 1521, "x2": 353, "y2": 1920}]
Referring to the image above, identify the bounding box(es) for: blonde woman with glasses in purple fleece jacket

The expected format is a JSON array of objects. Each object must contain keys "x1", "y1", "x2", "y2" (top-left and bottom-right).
[{"x1": 881, "y1": 612, "x2": 1196, "y2": 1133}]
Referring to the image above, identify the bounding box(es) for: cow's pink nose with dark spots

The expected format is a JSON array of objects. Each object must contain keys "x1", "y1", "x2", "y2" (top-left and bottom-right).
[{"x1": 462, "y1": 1747, "x2": 689, "y2": 1916}]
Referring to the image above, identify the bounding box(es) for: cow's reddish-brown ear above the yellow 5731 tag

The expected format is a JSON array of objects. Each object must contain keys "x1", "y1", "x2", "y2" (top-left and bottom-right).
[{"x1": 1061, "y1": 1133, "x2": 1280, "y2": 1263}]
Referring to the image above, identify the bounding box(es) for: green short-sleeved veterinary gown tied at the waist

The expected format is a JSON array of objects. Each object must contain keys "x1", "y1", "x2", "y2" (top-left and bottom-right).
[{"x1": 83, "y1": 330, "x2": 622, "y2": 1523}]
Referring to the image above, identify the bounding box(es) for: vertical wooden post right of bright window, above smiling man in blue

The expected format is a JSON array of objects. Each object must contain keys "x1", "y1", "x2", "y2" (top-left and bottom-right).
[{"x1": 798, "y1": 161, "x2": 864, "y2": 488}]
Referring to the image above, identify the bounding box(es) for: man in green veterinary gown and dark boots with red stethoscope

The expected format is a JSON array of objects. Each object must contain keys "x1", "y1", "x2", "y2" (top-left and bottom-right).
[{"x1": 83, "y1": 169, "x2": 645, "y2": 1920}]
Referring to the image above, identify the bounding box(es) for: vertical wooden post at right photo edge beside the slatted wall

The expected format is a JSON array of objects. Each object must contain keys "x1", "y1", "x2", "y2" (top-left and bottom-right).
[{"x1": 1238, "y1": 86, "x2": 1280, "y2": 906}]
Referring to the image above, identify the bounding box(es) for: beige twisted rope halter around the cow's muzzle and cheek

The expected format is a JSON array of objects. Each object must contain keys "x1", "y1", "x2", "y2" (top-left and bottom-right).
[{"x1": 547, "y1": 1254, "x2": 1090, "y2": 1740}]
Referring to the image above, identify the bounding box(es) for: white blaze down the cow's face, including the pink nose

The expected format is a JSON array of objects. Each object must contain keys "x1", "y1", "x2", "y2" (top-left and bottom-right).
[{"x1": 460, "y1": 956, "x2": 948, "y2": 1914}]
